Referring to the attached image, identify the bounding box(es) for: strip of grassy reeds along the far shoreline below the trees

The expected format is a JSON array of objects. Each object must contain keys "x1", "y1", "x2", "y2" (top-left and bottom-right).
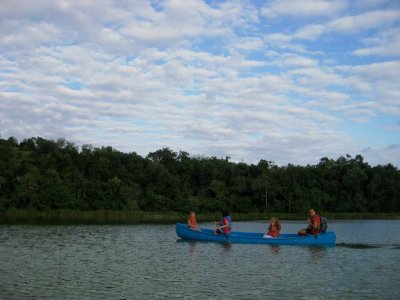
[{"x1": 0, "y1": 209, "x2": 400, "y2": 224}]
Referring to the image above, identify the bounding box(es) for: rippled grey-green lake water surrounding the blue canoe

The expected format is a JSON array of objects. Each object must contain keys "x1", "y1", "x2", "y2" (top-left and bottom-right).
[{"x1": 0, "y1": 221, "x2": 400, "y2": 299}]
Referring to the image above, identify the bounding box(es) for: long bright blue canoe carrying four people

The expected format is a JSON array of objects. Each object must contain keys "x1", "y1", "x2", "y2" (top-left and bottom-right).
[{"x1": 176, "y1": 223, "x2": 336, "y2": 246}]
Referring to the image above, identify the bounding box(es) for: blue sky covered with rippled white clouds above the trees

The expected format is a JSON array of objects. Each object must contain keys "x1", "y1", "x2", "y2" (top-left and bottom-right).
[{"x1": 0, "y1": 0, "x2": 400, "y2": 167}]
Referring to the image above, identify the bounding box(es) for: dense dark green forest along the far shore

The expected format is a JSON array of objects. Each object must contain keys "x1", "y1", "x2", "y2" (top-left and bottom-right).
[{"x1": 0, "y1": 137, "x2": 400, "y2": 213}]
